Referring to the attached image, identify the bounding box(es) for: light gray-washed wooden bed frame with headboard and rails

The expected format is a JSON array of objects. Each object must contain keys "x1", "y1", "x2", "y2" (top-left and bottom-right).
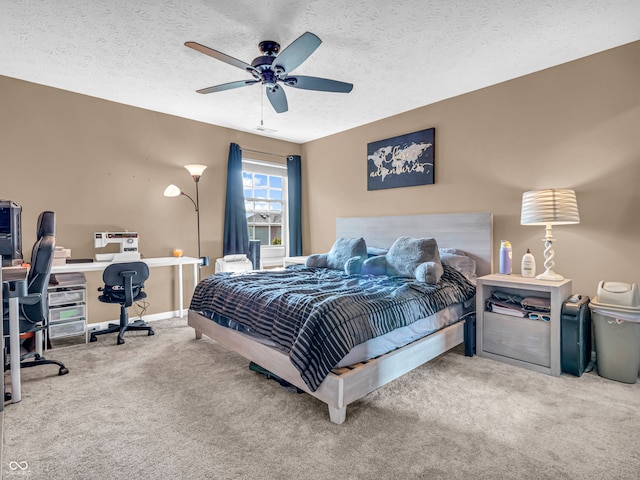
[{"x1": 188, "y1": 213, "x2": 493, "y2": 424}]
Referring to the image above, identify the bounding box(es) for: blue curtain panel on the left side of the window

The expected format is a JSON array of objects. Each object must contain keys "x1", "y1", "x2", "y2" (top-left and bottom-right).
[{"x1": 222, "y1": 143, "x2": 249, "y2": 255}]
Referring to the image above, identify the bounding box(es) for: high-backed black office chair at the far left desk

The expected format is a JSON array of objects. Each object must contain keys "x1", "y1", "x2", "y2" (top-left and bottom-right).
[{"x1": 3, "y1": 211, "x2": 69, "y2": 375}]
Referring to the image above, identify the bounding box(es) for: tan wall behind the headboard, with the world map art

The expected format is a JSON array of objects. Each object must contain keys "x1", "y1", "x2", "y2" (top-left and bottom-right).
[{"x1": 303, "y1": 42, "x2": 640, "y2": 296}]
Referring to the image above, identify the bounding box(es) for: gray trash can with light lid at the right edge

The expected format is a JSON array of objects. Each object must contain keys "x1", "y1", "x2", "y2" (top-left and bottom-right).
[{"x1": 589, "y1": 282, "x2": 640, "y2": 383}]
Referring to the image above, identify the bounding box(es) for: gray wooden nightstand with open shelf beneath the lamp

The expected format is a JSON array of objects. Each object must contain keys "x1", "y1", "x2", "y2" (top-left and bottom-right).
[{"x1": 476, "y1": 274, "x2": 571, "y2": 376}]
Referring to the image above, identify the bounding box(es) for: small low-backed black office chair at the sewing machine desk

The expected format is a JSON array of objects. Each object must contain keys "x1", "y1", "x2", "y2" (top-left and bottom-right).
[{"x1": 90, "y1": 262, "x2": 154, "y2": 345}]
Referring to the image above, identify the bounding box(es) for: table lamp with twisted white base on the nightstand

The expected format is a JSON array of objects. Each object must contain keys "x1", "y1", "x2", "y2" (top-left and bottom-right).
[{"x1": 520, "y1": 189, "x2": 580, "y2": 282}]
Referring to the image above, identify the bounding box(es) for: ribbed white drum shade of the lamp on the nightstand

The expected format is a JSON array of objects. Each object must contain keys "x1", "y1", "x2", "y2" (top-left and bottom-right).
[{"x1": 520, "y1": 188, "x2": 580, "y2": 225}]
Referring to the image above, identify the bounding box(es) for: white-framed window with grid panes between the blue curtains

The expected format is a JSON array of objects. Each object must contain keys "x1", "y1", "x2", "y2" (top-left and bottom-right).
[{"x1": 242, "y1": 159, "x2": 287, "y2": 249}]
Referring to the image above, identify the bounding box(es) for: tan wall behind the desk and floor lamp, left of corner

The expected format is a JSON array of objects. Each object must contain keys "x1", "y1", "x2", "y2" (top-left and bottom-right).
[{"x1": 0, "y1": 76, "x2": 301, "y2": 322}]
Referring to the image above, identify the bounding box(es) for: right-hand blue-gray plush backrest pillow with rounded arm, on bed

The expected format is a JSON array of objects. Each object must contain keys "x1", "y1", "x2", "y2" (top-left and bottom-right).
[{"x1": 386, "y1": 237, "x2": 444, "y2": 284}]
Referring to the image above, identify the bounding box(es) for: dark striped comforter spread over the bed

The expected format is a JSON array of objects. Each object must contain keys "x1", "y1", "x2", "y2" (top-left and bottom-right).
[{"x1": 190, "y1": 265, "x2": 475, "y2": 391}]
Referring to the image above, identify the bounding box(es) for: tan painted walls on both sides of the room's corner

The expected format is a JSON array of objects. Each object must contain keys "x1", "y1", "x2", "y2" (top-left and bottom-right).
[{"x1": 0, "y1": 42, "x2": 640, "y2": 322}]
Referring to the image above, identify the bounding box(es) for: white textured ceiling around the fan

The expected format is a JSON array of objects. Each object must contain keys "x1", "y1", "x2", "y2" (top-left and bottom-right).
[{"x1": 0, "y1": 0, "x2": 640, "y2": 143}]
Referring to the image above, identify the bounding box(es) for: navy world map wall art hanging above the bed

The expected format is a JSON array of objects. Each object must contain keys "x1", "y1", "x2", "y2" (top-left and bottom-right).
[{"x1": 367, "y1": 128, "x2": 436, "y2": 190}]
